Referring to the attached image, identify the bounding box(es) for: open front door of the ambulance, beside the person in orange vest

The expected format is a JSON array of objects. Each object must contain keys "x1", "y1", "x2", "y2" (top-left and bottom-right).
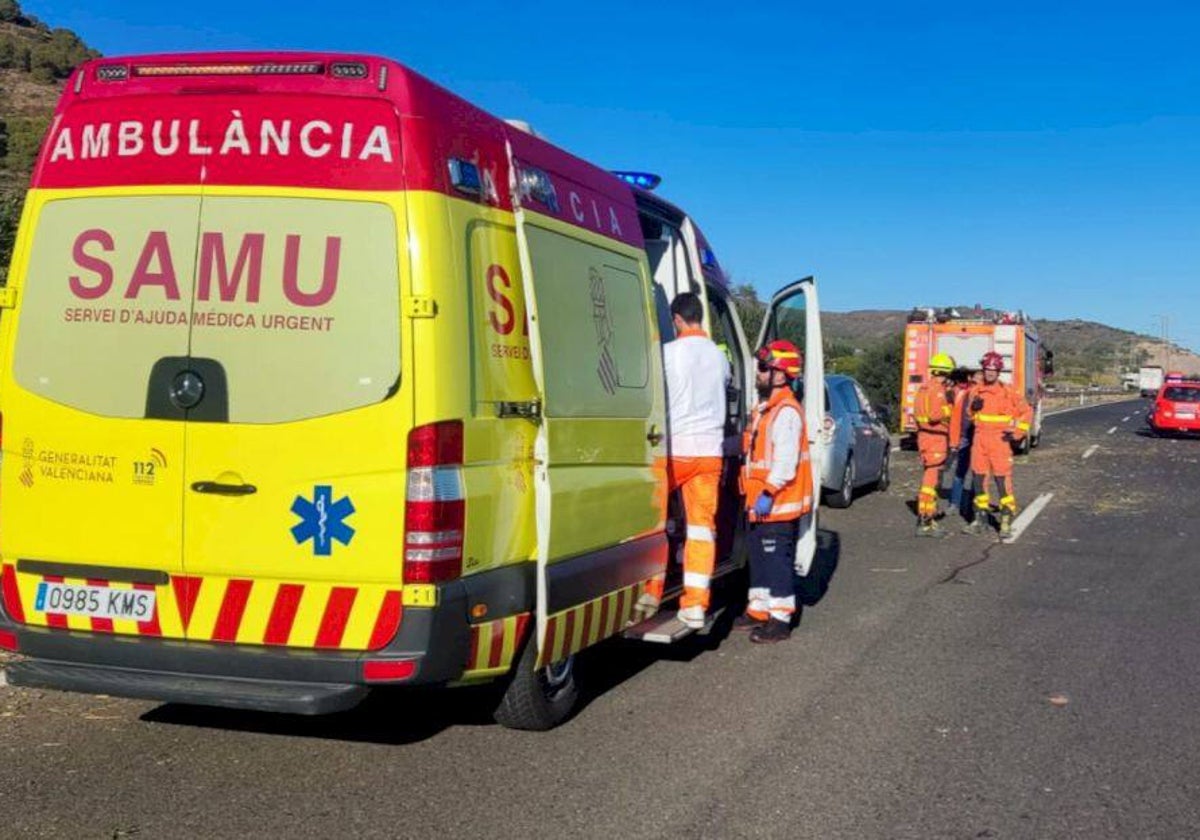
[{"x1": 755, "y1": 277, "x2": 826, "y2": 574}]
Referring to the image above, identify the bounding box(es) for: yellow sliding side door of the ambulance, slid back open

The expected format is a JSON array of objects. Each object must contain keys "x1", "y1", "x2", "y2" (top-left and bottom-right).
[{"x1": 510, "y1": 149, "x2": 667, "y2": 666}]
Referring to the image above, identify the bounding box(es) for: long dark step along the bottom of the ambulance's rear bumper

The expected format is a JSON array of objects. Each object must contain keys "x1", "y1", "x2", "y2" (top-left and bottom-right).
[{"x1": 5, "y1": 660, "x2": 368, "y2": 714}]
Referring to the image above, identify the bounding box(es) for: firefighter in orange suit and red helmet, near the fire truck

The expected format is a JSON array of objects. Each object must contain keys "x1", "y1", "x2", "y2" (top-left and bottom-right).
[{"x1": 964, "y1": 352, "x2": 1033, "y2": 536}]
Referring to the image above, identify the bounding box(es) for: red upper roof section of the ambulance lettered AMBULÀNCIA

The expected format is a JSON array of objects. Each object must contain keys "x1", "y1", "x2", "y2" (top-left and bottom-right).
[{"x1": 32, "y1": 53, "x2": 642, "y2": 247}]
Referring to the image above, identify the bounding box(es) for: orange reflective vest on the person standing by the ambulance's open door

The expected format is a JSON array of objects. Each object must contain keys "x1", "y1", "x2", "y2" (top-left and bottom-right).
[{"x1": 740, "y1": 388, "x2": 812, "y2": 522}]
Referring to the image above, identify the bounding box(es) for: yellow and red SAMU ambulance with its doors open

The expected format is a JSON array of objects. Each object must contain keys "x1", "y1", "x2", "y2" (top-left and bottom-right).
[{"x1": 0, "y1": 53, "x2": 824, "y2": 730}]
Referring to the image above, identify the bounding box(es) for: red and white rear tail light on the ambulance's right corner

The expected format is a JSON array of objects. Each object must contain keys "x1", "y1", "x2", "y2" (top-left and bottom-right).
[{"x1": 404, "y1": 420, "x2": 467, "y2": 583}]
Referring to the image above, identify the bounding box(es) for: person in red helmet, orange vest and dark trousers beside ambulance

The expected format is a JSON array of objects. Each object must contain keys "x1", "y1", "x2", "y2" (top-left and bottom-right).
[{"x1": 734, "y1": 341, "x2": 812, "y2": 643}]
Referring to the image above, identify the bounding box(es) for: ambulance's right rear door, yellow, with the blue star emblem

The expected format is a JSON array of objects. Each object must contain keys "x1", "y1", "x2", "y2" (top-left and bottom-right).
[{"x1": 172, "y1": 97, "x2": 412, "y2": 650}]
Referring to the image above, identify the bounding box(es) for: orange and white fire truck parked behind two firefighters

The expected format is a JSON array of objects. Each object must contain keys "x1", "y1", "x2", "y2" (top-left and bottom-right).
[{"x1": 900, "y1": 305, "x2": 1054, "y2": 452}]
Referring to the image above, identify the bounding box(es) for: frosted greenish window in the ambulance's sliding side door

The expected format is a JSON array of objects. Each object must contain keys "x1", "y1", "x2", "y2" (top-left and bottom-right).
[{"x1": 526, "y1": 226, "x2": 653, "y2": 418}]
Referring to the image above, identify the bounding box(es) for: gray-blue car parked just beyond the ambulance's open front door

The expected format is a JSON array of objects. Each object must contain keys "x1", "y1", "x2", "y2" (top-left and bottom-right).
[{"x1": 821, "y1": 374, "x2": 892, "y2": 508}]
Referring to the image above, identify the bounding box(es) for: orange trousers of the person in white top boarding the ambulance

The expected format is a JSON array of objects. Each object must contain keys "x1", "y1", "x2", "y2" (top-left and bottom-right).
[{"x1": 646, "y1": 456, "x2": 722, "y2": 610}]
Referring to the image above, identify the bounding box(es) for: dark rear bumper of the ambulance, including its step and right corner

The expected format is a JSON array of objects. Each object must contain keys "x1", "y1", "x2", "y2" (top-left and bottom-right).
[{"x1": 0, "y1": 573, "x2": 494, "y2": 714}]
